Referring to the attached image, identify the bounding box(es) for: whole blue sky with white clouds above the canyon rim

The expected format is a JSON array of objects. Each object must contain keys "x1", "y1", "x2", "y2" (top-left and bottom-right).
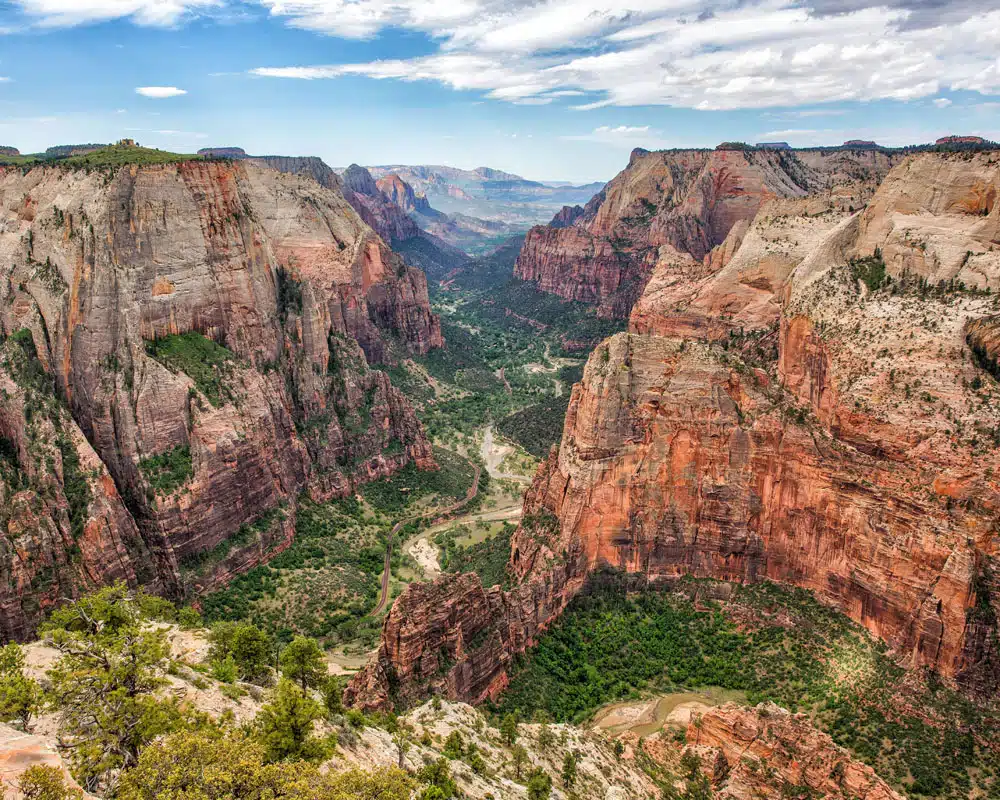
[{"x1": 0, "y1": 0, "x2": 1000, "y2": 182}]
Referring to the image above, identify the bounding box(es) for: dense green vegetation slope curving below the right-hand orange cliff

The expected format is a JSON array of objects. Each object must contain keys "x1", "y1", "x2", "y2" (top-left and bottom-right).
[{"x1": 499, "y1": 575, "x2": 1000, "y2": 797}]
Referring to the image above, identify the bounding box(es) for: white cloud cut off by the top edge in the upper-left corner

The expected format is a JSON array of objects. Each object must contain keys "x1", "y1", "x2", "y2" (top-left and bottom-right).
[{"x1": 15, "y1": 0, "x2": 224, "y2": 27}]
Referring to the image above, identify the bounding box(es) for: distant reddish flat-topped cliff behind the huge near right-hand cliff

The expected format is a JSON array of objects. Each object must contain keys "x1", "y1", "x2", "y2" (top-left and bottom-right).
[{"x1": 515, "y1": 150, "x2": 898, "y2": 317}]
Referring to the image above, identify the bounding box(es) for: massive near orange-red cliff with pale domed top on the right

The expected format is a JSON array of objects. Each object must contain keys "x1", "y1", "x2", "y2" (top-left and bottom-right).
[{"x1": 352, "y1": 148, "x2": 1000, "y2": 708}]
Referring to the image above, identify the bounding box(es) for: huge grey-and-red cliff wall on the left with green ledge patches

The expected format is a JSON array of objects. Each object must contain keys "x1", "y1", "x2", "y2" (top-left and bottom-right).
[{"x1": 0, "y1": 162, "x2": 443, "y2": 637}]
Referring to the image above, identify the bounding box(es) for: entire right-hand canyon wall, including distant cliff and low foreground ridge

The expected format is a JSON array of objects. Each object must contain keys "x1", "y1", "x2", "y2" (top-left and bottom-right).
[{"x1": 347, "y1": 150, "x2": 1000, "y2": 708}]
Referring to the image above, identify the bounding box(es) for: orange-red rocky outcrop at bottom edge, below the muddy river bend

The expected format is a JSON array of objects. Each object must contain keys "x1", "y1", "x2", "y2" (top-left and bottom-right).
[{"x1": 680, "y1": 703, "x2": 902, "y2": 800}]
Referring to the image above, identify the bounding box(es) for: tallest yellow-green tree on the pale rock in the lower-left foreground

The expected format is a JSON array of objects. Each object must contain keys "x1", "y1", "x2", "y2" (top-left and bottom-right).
[{"x1": 46, "y1": 584, "x2": 181, "y2": 794}]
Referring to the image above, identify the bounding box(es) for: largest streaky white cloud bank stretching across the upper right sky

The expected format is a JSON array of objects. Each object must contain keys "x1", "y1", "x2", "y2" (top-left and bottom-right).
[{"x1": 253, "y1": 0, "x2": 1000, "y2": 114}]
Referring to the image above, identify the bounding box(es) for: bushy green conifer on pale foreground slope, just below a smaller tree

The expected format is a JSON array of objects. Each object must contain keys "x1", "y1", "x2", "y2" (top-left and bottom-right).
[{"x1": 257, "y1": 678, "x2": 328, "y2": 761}]
